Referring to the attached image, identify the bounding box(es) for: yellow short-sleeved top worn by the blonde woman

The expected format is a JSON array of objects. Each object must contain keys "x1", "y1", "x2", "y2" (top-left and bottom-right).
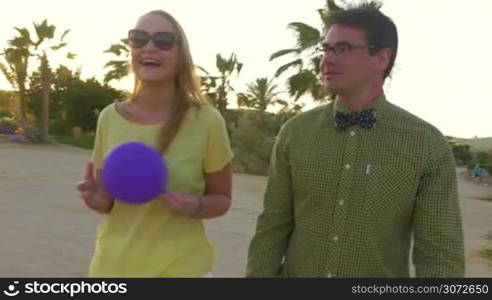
[{"x1": 89, "y1": 104, "x2": 233, "y2": 277}]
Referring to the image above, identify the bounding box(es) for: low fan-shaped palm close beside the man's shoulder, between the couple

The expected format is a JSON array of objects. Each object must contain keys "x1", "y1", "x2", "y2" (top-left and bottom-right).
[{"x1": 237, "y1": 77, "x2": 283, "y2": 112}]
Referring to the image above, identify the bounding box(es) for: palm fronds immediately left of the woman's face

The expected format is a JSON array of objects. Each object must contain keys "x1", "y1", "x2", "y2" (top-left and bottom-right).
[{"x1": 104, "y1": 39, "x2": 130, "y2": 84}]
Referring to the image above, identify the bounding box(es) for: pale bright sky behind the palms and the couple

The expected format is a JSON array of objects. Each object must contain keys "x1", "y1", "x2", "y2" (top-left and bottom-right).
[{"x1": 0, "y1": 0, "x2": 492, "y2": 138}]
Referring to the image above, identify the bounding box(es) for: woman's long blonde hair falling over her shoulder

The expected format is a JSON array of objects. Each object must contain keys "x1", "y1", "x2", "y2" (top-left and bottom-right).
[{"x1": 130, "y1": 10, "x2": 207, "y2": 153}]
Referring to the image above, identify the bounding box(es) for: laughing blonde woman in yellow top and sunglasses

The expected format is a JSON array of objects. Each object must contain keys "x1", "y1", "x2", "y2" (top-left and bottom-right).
[{"x1": 77, "y1": 11, "x2": 233, "y2": 277}]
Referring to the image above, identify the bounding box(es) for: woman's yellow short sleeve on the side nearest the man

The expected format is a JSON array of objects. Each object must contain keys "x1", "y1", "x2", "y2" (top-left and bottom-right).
[{"x1": 204, "y1": 108, "x2": 234, "y2": 173}]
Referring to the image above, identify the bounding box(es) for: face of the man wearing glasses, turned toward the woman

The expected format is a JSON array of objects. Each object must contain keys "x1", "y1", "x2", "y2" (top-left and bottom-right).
[{"x1": 321, "y1": 24, "x2": 384, "y2": 95}]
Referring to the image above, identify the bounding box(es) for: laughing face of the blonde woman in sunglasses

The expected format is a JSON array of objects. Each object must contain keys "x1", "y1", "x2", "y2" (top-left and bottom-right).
[{"x1": 128, "y1": 14, "x2": 179, "y2": 83}]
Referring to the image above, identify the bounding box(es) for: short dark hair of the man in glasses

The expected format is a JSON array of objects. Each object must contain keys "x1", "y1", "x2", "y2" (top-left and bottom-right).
[{"x1": 325, "y1": 6, "x2": 398, "y2": 79}]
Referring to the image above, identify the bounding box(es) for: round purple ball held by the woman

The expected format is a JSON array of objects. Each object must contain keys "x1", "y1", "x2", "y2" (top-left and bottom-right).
[{"x1": 101, "y1": 142, "x2": 168, "y2": 204}]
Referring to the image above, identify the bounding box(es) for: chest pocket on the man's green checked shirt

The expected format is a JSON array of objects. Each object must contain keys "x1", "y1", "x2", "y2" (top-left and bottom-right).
[{"x1": 364, "y1": 165, "x2": 417, "y2": 216}]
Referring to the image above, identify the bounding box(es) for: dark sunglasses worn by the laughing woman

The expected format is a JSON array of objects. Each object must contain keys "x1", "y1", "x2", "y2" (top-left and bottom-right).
[{"x1": 127, "y1": 29, "x2": 178, "y2": 51}]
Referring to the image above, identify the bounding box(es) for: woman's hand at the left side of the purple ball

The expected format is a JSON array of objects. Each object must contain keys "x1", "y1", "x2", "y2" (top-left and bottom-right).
[{"x1": 77, "y1": 162, "x2": 114, "y2": 213}]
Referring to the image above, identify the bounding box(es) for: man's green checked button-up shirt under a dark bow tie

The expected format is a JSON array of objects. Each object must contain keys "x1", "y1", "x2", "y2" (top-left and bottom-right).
[{"x1": 247, "y1": 95, "x2": 464, "y2": 277}]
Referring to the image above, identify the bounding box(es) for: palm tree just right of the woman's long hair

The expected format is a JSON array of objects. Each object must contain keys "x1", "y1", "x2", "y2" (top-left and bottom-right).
[{"x1": 198, "y1": 53, "x2": 243, "y2": 116}]
